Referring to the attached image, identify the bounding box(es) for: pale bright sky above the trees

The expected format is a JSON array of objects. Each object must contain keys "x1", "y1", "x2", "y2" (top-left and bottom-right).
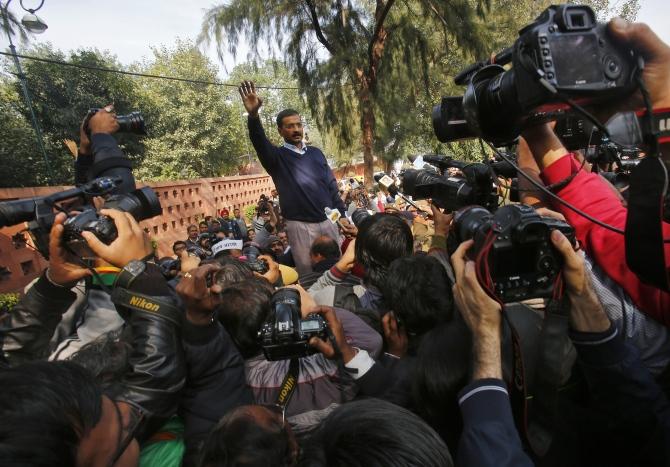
[{"x1": 0, "y1": 0, "x2": 670, "y2": 78}]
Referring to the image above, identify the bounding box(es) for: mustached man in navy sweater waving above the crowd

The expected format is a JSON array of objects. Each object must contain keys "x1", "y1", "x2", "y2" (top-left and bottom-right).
[{"x1": 239, "y1": 81, "x2": 346, "y2": 275}]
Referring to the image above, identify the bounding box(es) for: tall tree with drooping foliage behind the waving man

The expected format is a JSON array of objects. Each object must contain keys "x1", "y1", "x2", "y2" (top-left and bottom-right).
[{"x1": 201, "y1": 0, "x2": 486, "y2": 184}]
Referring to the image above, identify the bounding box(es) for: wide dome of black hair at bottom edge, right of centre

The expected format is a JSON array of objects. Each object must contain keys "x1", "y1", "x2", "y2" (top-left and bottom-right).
[{"x1": 300, "y1": 399, "x2": 453, "y2": 467}]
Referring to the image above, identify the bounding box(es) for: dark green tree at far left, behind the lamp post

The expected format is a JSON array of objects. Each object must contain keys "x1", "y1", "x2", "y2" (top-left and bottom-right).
[{"x1": 0, "y1": 45, "x2": 143, "y2": 186}]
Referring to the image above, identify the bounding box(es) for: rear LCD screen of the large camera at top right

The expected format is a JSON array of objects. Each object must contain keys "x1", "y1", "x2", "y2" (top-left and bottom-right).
[{"x1": 551, "y1": 34, "x2": 603, "y2": 86}]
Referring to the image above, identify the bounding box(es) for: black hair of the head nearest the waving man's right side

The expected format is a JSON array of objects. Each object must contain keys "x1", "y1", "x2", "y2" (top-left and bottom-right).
[{"x1": 356, "y1": 214, "x2": 414, "y2": 289}]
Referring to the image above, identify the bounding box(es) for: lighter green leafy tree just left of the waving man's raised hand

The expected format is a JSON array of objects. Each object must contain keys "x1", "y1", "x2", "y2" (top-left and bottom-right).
[{"x1": 137, "y1": 41, "x2": 245, "y2": 180}]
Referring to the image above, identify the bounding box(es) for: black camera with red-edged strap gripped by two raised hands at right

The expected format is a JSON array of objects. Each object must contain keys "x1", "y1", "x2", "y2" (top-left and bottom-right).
[{"x1": 448, "y1": 204, "x2": 575, "y2": 303}]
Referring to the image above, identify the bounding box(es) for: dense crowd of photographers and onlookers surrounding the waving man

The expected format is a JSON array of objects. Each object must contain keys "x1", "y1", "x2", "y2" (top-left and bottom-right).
[{"x1": 0, "y1": 12, "x2": 670, "y2": 467}]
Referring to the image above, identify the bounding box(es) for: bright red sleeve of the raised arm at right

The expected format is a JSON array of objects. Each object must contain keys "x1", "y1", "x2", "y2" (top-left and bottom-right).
[{"x1": 540, "y1": 154, "x2": 670, "y2": 326}]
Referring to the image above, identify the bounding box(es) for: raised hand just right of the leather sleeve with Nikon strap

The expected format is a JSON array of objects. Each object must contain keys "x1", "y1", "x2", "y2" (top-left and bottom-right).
[{"x1": 176, "y1": 264, "x2": 223, "y2": 325}]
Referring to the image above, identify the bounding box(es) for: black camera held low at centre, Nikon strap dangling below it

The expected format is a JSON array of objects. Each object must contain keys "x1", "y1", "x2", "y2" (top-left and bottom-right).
[{"x1": 258, "y1": 289, "x2": 329, "y2": 361}]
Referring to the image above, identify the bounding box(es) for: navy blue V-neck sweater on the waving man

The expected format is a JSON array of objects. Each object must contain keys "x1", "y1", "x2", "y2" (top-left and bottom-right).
[{"x1": 247, "y1": 117, "x2": 346, "y2": 222}]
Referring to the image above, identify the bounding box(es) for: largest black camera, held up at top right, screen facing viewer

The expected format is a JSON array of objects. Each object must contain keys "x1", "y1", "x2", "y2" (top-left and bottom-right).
[{"x1": 433, "y1": 5, "x2": 638, "y2": 146}]
